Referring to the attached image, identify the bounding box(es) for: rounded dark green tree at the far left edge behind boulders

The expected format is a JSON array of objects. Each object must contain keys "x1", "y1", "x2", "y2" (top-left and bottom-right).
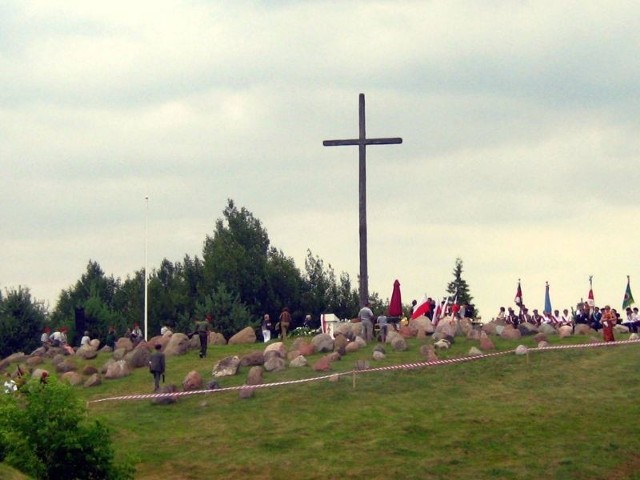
[{"x1": 0, "y1": 287, "x2": 47, "y2": 358}]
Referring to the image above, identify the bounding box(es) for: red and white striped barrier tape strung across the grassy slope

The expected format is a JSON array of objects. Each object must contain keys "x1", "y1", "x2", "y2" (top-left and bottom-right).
[{"x1": 87, "y1": 340, "x2": 640, "y2": 404}]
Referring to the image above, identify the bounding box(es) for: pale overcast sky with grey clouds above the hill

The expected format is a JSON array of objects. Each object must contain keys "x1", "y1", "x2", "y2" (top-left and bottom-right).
[{"x1": 0, "y1": 0, "x2": 640, "y2": 318}]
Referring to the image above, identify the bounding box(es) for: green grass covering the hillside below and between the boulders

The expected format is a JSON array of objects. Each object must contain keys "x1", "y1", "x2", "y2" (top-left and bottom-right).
[{"x1": 7, "y1": 337, "x2": 640, "y2": 480}]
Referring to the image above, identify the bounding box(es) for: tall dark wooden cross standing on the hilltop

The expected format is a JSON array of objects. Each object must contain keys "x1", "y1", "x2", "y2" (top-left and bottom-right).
[{"x1": 322, "y1": 93, "x2": 402, "y2": 306}]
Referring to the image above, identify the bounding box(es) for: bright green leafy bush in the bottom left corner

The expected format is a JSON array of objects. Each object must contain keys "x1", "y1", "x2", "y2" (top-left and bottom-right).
[{"x1": 0, "y1": 379, "x2": 134, "y2": 480}]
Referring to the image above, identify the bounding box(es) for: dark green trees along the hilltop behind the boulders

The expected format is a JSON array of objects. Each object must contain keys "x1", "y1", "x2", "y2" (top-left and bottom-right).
[{"x1": 0, "y1": 200, "x2": 472, "y2": 356}]
